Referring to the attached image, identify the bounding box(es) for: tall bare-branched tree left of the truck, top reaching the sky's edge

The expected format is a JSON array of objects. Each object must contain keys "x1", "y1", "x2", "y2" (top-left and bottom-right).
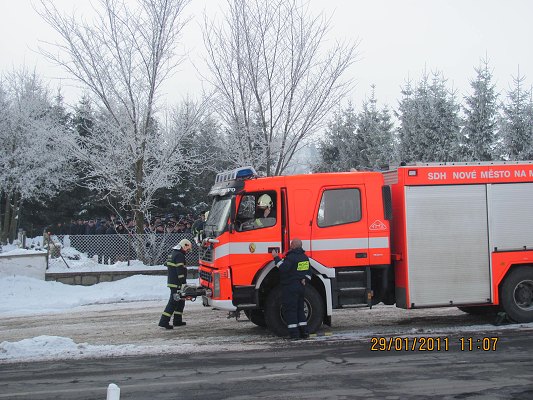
[{"x1": 38, "y1": 0, "x2": 198, "y2": 232}]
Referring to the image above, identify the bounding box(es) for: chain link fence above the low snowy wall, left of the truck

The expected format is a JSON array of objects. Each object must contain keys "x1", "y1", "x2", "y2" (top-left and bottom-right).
[{"x1": 43, "y1": 233, "x2": 198, "y2": 267}]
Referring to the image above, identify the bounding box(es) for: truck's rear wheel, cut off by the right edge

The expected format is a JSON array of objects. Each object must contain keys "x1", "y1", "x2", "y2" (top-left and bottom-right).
[{"x1": 501, "y1": 267, "x2": 533, "y2": 322}]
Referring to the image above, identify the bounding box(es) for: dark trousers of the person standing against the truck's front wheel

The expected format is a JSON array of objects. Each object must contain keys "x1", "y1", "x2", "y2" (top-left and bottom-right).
[{"x1": 281, "y1": 281, "x2": 307, "y2": 337}]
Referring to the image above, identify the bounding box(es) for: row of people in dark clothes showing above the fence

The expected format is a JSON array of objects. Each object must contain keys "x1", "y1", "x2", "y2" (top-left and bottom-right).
[{"x1": 46, "y1": 213, "x2": 205, "y2": 235}]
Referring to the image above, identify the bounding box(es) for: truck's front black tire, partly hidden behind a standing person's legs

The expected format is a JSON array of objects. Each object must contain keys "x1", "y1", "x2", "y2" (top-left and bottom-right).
[{"x1": 265, "y1": 285, "x2": 324, "y2": 336}]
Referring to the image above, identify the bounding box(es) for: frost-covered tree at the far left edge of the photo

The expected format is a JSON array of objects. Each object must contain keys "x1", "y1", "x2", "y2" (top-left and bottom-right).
[{"x1": 0, "y1": 69, "x2": 72, "y2": 242}]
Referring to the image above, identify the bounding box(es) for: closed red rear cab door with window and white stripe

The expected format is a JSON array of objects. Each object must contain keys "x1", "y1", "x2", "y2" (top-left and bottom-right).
[{"x1": 310, "y1": 185, "x2": 369, "y2": 267}]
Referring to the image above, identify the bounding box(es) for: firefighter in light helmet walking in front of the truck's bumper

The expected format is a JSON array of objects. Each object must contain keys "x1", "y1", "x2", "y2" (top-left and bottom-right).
[{"x1": 159, "y1": 239, "x2": 192, "y2": 329}]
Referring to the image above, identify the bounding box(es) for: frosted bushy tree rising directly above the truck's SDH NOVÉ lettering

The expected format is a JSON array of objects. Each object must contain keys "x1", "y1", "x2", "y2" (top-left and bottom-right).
[{"x1": 397, "y1": 72, "x2": 460, "y2": 162}]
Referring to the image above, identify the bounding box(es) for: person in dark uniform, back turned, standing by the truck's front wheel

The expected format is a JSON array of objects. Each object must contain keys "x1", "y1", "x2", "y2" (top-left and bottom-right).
[{"x1": 272, "y1": 239, "x2": 311, "y2": 339}]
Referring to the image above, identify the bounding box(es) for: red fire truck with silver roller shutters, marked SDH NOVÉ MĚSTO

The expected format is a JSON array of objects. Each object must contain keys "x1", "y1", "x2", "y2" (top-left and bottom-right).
[{"x1": 193, "y1": 162, "x2": 533, "y2": 335}]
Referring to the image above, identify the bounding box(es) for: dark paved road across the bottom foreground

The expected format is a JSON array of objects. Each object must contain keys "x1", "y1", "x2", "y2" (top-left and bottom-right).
[{"x1": 0, "y1": 329, "x2": 533, "y2": 400}]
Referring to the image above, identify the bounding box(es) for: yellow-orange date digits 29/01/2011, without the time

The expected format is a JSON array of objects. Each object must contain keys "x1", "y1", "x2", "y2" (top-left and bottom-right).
[{"x1": 370, "y1": 336, "x2": 450, "y2": 351}]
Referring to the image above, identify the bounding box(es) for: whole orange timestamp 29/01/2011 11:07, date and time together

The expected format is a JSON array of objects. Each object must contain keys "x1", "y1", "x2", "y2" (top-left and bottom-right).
[{"x1": 370, "y1": 336, "x2": 499, "y2": 351}]
